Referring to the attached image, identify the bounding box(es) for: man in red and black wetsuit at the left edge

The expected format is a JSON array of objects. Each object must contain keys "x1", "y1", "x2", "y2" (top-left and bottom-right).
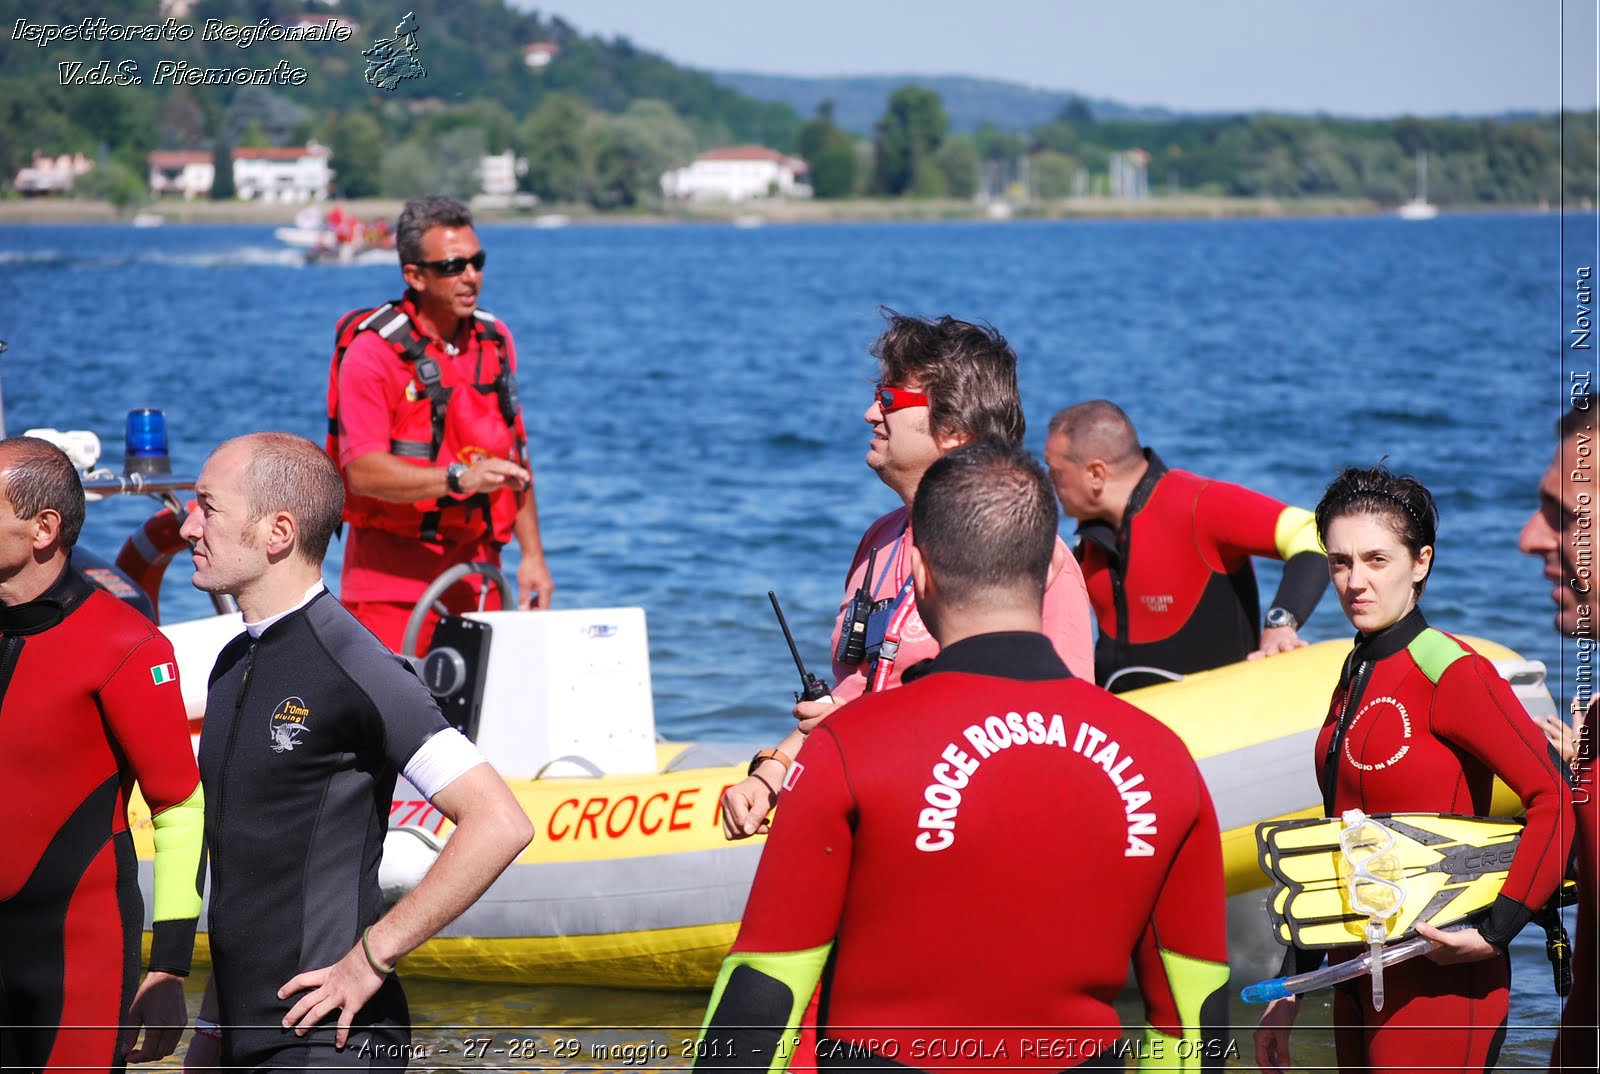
[{"x1": 0, "y1": 437, "x2": 203, "y2": 1071}]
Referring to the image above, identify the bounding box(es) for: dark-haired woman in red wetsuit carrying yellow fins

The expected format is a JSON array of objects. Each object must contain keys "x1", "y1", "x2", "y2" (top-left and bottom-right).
[{"x1": 1256, "y1": 466, "x2": 1571, "y2": 1071}]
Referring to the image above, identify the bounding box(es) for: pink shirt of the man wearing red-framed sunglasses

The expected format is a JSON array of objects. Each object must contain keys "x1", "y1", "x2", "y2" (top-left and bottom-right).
[{"x1": 829, "y1": 507, "x2": 1094, "y2": 704}]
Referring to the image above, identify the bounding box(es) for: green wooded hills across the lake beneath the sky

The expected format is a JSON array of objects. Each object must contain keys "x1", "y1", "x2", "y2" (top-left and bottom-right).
[{"x1": 0, "y1": 0, "x2": 1595, "y2": 208}]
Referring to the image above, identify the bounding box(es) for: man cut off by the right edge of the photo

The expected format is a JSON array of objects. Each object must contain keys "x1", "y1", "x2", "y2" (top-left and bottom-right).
[{"x1": 1517, "y1": 392, "x2": 1600, "y2": 1071}]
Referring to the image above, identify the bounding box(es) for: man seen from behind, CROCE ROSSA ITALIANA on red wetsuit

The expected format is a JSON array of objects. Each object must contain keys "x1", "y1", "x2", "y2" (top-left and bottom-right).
[{"x1": 696, "y1": 440, "x2": 1232, "y2": 1071}]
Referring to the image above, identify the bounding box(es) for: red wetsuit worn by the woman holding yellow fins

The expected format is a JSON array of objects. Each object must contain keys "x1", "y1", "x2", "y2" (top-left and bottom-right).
[{"x1": 1315, "y1": 610, "x2": 1573, "y2": 1071}]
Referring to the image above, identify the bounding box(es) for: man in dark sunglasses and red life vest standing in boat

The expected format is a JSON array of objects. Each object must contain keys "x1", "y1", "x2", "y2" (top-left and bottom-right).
[{"x1": 328, "y1": 195, "x2": 554, "y2": 651}]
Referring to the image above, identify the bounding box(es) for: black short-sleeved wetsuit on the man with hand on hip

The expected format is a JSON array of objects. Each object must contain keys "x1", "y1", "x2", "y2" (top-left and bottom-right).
[{"x1": 200, "y1": 591, "x2": 446, "y2": 1068}]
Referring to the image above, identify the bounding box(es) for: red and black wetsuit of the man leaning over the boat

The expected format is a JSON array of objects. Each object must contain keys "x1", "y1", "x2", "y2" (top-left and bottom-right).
[{"x1": 1077, "y1": 450, "x2": 1328, "y2": 693}]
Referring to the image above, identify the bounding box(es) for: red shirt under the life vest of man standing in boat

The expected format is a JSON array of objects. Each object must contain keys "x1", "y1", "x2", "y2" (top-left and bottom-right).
[{"x1": 338, "y1": 323, "x2": 515, "y2": 602}]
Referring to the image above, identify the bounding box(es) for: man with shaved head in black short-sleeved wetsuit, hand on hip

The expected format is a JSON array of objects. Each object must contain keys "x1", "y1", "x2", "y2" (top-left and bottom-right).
[{"x1": 182, "y1": 432, "x2": 533, "y2": 1071}]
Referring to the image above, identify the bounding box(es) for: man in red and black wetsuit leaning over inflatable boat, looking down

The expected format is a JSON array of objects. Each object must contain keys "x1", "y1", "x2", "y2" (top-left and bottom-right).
[{"x1": 1045, "y1": 399, "x2": 1328, "y2": 693}]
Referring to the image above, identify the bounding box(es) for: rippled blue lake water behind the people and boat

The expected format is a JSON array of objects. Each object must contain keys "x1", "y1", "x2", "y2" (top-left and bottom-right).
[{"x1": 0, "y1": 214, "x2": 1595, "y2": 1069}]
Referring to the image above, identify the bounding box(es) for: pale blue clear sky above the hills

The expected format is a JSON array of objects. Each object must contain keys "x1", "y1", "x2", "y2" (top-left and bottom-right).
[{"x1": 518, "y1": 0, "x2": 1600, "y2": 117}]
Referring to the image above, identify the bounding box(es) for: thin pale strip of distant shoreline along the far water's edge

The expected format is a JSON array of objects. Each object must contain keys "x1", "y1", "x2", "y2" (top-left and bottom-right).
[{"x1": 0, "y1": 195, "x2": 1555, "y2": 226}]
